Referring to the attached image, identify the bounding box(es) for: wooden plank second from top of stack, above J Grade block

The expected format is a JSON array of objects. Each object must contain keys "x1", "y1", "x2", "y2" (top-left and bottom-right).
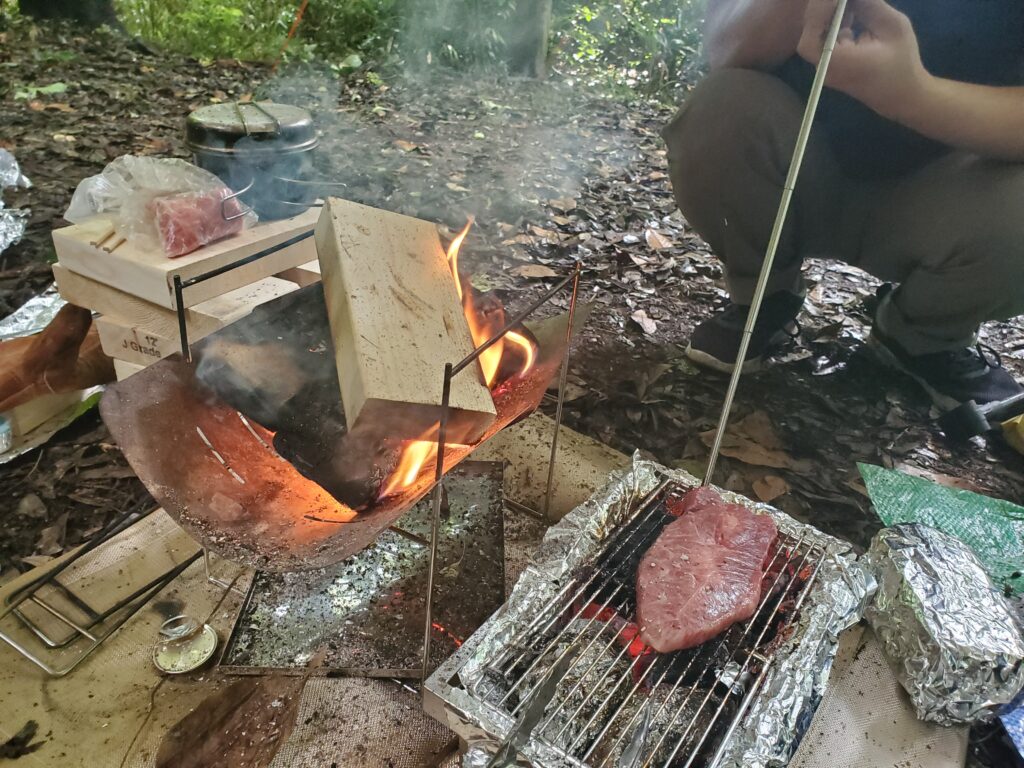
[{"x1": 53, "y1": 263, "x2": 295, "y2": 339}]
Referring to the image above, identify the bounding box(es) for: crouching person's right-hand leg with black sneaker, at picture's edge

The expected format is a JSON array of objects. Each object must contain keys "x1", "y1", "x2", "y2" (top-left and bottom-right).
[{"x1": 858, "y1": 153, "x2": 1024, "y2": 407}]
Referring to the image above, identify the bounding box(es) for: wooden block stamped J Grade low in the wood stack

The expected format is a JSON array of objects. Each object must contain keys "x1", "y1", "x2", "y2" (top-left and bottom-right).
[{"x1": 95, "y1": 278, "x2": 297, "y2": 366}]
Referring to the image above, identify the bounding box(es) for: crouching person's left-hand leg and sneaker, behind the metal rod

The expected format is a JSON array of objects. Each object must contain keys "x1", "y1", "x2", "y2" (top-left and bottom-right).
[{"x1": 662, "y1": 70, "x2": 846, "y2": 371}]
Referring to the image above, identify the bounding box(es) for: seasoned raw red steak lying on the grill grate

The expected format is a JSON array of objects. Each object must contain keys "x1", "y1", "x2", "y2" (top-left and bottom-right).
[{"x1": 637, "y1": 488, "x2": 778, "y2": 653}]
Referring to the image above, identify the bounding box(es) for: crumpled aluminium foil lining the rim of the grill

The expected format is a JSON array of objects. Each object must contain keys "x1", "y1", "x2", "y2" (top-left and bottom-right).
[{"x1": 427, "y1": 456, "x2": 874, "y2": 768}]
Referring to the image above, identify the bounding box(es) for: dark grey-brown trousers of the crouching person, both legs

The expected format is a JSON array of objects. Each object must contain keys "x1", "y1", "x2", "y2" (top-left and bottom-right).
[{"x1": 663, "y1": 70, "x2": 1024, "y2": 354}]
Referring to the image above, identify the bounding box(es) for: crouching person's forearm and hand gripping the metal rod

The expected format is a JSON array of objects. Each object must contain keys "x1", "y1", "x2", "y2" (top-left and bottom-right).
[{"x1": 799, "y1": 0, "x2": 1024, "y2": 161}]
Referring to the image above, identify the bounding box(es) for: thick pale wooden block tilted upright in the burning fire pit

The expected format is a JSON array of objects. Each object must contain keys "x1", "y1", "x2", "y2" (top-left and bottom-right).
[{"x1": 316, "y1": 198, "x2": 495, "y2": 442}]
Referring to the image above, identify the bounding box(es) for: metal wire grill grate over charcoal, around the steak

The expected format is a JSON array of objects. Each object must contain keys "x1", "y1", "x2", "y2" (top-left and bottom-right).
[{"x1": 482, "y1": 482, "x2": 825, "y2": 768}]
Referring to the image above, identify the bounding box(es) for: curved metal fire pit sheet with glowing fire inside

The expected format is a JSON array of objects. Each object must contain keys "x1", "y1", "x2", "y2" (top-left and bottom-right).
[{"x1": 101, "y1": 204, "x2": 567, "y2": 570}]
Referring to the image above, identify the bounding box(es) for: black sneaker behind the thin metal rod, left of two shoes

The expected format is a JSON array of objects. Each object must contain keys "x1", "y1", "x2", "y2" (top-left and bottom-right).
[{"x1": 686, "y1": 291, "x2": 804, "y2": 374}]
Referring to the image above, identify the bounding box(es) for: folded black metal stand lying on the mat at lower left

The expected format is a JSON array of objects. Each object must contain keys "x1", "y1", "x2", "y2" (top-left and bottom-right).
[{"x1": 0, "y1": 501, "x2": 203, "y2": 677}]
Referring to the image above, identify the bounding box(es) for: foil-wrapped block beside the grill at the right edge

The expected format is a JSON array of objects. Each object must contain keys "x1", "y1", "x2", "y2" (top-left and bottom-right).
[{"x1": 865, "y1": 523, "x2": 1024, "y2": 725}]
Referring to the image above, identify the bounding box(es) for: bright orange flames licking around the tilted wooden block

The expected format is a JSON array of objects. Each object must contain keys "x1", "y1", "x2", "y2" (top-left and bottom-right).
[{"x1": 380, "y1": 217, "x2": 537, "y2": 498}]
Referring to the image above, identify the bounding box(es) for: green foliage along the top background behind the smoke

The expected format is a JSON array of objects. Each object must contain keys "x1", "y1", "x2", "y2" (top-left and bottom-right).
[{"x1": 101, "y1": 0, "x2": 703, "y2": 94}]
